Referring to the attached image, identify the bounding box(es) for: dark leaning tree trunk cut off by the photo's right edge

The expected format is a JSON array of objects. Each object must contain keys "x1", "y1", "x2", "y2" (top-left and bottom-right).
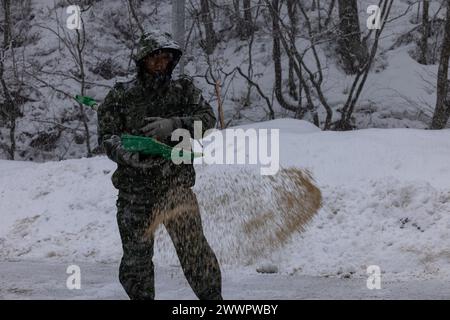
[{"x1": 431, "y1": 0, "x2": 450, "y2": 129}]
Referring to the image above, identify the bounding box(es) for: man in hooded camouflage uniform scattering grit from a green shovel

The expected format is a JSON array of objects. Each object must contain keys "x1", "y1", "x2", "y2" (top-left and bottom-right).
[{"x1": 98, "y1": 31, "x2": 222, "y2": 300}]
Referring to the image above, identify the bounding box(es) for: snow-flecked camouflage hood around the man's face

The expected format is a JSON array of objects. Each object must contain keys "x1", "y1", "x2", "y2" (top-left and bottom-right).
[{"x1": 134, "y1": 30, "x2": 183, "y2": 87}]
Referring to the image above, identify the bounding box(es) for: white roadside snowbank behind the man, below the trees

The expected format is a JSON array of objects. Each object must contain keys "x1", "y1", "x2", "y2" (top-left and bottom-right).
[{"x1": 0, "y1": 119, "x2": 450, "y2": 298}]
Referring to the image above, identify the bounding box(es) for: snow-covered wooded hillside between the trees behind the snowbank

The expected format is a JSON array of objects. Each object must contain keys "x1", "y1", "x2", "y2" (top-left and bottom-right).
[{"x1": 0, "y1": 0, "x2": 445, "y2": 161}]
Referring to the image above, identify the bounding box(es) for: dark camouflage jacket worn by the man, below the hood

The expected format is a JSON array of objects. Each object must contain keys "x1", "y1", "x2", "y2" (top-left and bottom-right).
[{"x1": 98, "y1": 76, "x2": 216, "y2": 194}]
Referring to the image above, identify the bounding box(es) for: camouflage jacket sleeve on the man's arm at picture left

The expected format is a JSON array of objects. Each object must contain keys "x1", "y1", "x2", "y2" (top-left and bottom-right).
[{"x1": 97, "y1": 85, "x2": 123, "y2": 163}]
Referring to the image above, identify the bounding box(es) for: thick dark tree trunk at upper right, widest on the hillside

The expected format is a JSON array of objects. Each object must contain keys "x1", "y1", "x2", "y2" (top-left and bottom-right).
[{"x1": 338, "y1": 0, "x2": 367, "y2": 74}]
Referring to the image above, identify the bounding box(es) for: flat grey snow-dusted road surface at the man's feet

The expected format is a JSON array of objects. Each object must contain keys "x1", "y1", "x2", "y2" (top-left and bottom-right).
[{"x1": 0, "y1": 261, "x2": 450, "y2": 299}]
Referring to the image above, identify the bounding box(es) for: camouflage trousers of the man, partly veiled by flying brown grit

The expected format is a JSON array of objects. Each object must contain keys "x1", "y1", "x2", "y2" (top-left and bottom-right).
[{"x1": 117, "y1": 188, "x2": 222, "y2": 300}]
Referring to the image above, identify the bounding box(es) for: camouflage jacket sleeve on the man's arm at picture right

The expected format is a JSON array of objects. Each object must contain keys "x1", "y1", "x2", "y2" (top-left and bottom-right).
[{"x1": 175, "y1": 80, "x2": 216, "y2": 137}]
